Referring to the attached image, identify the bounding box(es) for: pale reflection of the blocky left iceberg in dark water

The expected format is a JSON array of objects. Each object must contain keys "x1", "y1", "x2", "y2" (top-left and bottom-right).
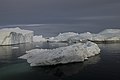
[{"x1": 0, "y1": 44, "x2": 33, "y2": 62}]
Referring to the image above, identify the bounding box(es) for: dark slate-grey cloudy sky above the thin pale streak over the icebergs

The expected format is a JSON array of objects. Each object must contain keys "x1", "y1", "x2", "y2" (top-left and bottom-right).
[{"x1": 0, "y1": 0, "x2": 120, "y2": 25}]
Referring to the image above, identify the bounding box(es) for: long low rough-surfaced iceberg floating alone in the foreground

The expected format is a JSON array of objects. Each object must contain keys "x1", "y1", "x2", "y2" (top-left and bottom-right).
[{"x1": 19, "y1": 41, "x2": 100, "y2": 66}]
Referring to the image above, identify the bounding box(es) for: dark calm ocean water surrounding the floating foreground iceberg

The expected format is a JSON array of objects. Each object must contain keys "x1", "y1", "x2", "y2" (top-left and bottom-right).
[{"x1": 0, "y1": 43, "x2": 120, "y2": 80}]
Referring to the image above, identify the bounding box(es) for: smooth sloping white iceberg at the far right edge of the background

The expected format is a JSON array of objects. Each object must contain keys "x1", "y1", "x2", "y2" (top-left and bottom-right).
[{"x1": 91, "y1": 29, "x2": 120, "y2": 42}]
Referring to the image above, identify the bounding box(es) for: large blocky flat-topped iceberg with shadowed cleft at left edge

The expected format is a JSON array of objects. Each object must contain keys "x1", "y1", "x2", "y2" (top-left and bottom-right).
[{"x1": 0, "y1": 27, "x2": 34, "y2": 45}]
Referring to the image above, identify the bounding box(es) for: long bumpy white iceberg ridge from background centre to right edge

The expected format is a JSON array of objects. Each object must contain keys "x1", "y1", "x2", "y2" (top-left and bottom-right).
[{"x1": 48, "y1": 29, "x2": 120, "y2": 43}]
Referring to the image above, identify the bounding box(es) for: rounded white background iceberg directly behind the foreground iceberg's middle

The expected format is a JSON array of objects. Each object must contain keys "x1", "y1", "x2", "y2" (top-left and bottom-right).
[{"x1": 48, "y1": 32, "x2": 78, "y2": 42}]
